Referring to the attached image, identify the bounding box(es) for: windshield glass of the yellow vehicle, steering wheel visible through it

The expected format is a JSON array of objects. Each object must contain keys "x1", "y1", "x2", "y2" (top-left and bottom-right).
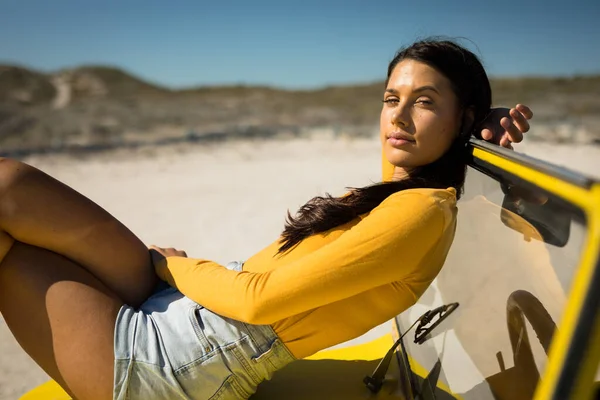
[{"x1": 399, "y1": 168, "x2": 586, "y2": 400}]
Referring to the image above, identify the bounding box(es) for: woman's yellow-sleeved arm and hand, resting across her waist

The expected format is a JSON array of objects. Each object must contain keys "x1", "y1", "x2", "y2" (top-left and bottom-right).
[{"x1": 156, "y1": 192, "x2": 444, "y2": 324}]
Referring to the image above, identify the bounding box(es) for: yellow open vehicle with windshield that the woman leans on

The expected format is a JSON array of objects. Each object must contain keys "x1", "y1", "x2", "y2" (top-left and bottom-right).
[{"x1": 21, "y1": 139, "x2": 600, "y2": 400}]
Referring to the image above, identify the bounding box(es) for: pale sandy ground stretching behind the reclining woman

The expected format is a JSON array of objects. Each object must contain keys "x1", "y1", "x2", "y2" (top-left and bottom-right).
[{"x1": 0, "y1": 138, "x2": 600, "y2": 400}]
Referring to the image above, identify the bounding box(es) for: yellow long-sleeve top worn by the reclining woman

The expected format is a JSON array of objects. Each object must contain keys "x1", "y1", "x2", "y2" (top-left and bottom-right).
[{"x1": 156, "y1": 155, "x2": 456, "y2": 358}]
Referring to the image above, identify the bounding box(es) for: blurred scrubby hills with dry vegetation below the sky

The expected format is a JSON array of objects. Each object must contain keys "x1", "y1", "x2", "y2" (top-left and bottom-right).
[{"x1": 0, "y1": 66, "x2": 600, "y2": 154}]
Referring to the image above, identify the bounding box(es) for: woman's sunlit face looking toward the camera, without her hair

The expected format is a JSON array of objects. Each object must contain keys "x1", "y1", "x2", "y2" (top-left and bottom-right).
[{"x1": 380, "y1": 59, "x2": 463, "y2": 176}]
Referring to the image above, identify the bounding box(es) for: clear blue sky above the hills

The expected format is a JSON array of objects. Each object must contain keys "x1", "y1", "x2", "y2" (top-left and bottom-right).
[{"x1": 0, "y1": 0, "x2": 600, "y2": 88}]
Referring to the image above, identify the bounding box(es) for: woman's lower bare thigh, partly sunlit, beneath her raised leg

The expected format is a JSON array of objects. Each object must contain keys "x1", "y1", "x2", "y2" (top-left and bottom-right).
[{"x1": 0, "y1": 242, "x2": 123, "y2": 399}]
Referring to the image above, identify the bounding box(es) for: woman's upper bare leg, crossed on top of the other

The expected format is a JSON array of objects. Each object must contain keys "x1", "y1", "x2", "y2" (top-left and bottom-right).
[{"x1": 0, "y1": 159, "x2": 157, "y2": 306}]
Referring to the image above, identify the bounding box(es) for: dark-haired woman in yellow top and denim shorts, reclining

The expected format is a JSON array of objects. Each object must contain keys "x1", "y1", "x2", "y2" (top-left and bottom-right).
[{"x1": 0, "y1": 41, "x2": 531, "y2": 399}]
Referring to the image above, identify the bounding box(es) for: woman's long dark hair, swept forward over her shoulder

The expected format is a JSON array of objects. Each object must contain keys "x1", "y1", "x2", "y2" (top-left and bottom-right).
[{"x1": 279, "y1": 39, "x2": 492, "y2": 253}]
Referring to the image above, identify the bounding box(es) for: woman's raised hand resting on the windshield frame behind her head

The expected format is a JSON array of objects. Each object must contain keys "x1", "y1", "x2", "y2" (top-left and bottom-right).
[{"x1": 481, "y1": 104, "x2": 533, "y2": 149}]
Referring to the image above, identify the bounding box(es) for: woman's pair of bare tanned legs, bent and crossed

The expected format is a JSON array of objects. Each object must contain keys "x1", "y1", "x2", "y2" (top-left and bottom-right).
[{"x1": 0, "y1": 159, "x2": 162, "y2": 399}]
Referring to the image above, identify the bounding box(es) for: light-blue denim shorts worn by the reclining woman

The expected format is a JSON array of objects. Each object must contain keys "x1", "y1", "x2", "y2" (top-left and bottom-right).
[{"x1": 113, "y1": 262, "x2": 295, "y2": 400}]
